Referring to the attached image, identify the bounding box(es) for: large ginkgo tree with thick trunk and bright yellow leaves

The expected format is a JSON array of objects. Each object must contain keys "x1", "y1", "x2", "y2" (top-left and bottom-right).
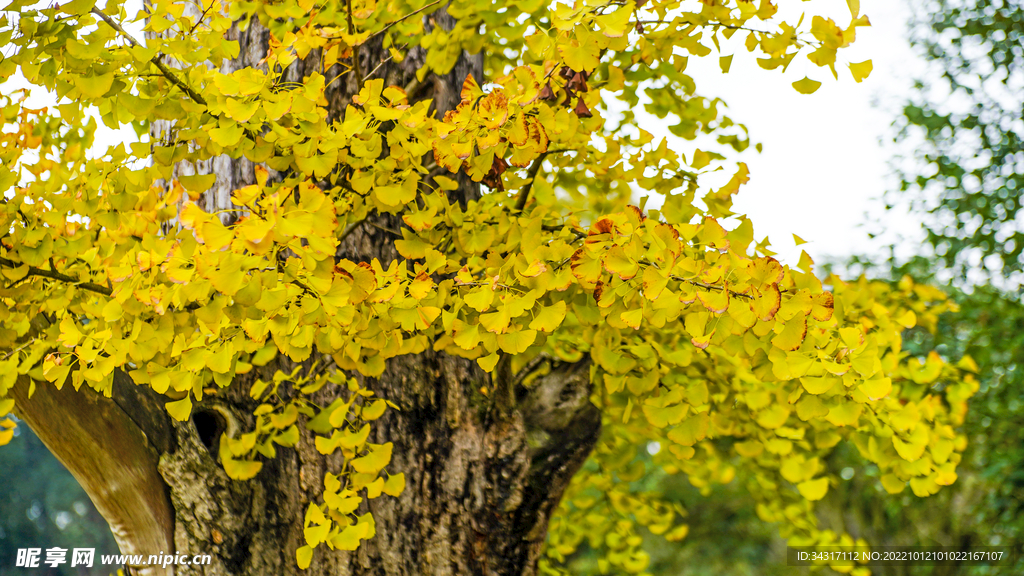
[{"x1": 0, "y1": 0, "x2": 977, "y2": 574}]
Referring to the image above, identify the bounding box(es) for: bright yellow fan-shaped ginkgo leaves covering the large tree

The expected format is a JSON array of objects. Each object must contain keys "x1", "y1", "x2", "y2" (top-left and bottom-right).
[{"x1": 0, "y1": 0, "x2": 975, "y2": 573}]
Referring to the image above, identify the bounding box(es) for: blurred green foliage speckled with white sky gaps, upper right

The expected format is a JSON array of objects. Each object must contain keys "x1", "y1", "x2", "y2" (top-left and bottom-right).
[{"x1": 890, "y1": 0, "x2": 1024, "y2": 283}]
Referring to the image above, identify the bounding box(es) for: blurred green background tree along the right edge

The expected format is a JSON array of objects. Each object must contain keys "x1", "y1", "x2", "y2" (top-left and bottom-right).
[{"x1": 856, "y1": 0, "x2": 1024, "y2": 574}]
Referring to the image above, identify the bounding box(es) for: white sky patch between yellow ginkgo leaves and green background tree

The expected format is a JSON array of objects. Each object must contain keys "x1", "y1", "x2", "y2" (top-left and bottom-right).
[{"x1": 663, "y1": 0, "x2": 925, "y2": 264}]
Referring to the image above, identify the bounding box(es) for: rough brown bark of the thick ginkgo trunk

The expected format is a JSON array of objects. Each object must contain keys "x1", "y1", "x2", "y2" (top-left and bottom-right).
[{"x1": 12, "y1": 5, "x2": 600, "y2": 576}]
